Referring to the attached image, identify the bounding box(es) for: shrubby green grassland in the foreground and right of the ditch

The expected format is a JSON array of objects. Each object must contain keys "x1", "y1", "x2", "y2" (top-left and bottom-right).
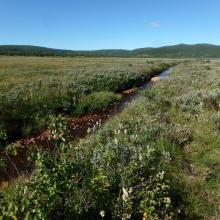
[{"x1": 0, "y1": 58, "x2": 220, "y2": 220}]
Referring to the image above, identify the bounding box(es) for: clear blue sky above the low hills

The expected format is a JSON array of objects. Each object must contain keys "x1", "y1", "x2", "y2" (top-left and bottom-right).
[{"x1": 0, "y1": 0, "x2": 220, "y2": 50}]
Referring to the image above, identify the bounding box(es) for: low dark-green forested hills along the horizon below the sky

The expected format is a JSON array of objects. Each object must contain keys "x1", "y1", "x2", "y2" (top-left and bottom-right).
[{"x1": 0, "y1": 44, "x2": 220, "y2": 58}]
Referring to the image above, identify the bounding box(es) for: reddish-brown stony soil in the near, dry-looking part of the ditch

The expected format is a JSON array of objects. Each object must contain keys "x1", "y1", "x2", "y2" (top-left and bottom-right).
[{"x1": 0, "y1": 110, "x2": 116, "y2": 184}]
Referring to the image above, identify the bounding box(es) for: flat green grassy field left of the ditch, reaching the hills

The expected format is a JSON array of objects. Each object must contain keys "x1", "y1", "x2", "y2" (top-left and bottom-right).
[{"x1": 0, "y1": 56, "x2": 172, "y2": 139}]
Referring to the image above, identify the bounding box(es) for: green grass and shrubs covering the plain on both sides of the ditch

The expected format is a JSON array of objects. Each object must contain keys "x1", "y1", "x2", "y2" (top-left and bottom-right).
[{"x1": 0, "y1": 57, "x2": 220, "y2": 220}]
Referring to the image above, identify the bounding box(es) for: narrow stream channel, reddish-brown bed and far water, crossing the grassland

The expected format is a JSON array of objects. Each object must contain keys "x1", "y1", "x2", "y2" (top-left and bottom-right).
[{"x1": 0, "y1": 68, "x2": 173, "y2": 183}]
